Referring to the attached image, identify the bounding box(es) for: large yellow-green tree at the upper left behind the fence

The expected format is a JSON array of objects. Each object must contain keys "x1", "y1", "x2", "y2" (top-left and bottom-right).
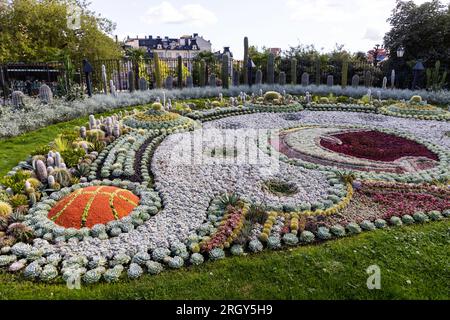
[{"x1": 0, "y1": 0, "x2": 121, "y2": 62}]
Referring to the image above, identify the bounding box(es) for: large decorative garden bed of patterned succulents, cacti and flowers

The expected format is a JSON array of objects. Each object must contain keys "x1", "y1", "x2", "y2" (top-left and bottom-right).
[{"x1": 0, "y1": 91, "x2": 450, "y2": 283}]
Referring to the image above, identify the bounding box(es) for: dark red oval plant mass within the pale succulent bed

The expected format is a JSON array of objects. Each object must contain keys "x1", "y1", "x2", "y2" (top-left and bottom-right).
[{"x1": 320, "y1": 131, "x2": 439, "y2": 162}]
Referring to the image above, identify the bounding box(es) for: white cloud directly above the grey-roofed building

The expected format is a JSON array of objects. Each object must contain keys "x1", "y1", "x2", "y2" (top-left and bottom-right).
[{"x1": 144, "y1": 1, "x2": 217, "y2": 27}]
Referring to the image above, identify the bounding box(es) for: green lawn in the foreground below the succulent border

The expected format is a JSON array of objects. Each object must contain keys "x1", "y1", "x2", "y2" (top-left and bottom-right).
[{"x1": 0, "y1": 220, "x2": 450, "y2": 300}]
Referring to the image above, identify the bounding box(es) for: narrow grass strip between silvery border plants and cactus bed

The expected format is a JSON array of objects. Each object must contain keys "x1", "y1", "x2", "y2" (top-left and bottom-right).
[{"x1": 0, "y1": 106, "x2": 143, "y2": 177}]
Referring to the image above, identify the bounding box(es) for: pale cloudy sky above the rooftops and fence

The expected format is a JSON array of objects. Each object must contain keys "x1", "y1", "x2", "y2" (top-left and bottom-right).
[{"x1": 90, "y1": 0, "x2": 448, "y2": 59}]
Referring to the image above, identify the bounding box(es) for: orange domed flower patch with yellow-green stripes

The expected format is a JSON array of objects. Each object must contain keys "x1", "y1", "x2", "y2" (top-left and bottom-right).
[{"x1": 48, "y1": 186, "x2": 139, "y2": 229}]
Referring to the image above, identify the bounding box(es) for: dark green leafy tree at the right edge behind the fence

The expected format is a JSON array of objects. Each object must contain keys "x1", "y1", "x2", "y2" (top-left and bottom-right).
[{"x1": 384, "y1": 0, "x2": 450, "y2": 87}]
